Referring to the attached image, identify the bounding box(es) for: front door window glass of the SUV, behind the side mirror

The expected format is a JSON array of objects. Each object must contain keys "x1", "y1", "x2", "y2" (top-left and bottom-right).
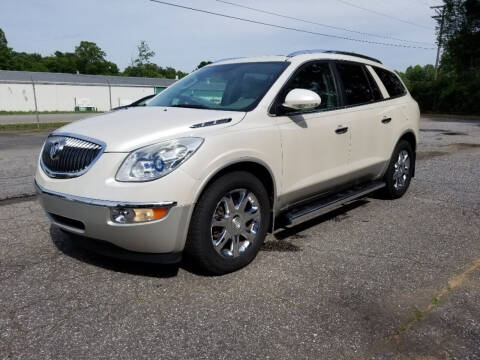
[{"x1": 279, "y1": 62, "x2": 339, "y2": 113}]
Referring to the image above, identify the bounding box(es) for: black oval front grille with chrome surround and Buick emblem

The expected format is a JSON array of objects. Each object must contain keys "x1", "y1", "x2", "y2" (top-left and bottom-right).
[{"x1": 41, "y1": 134, "x2": 105, "y2": 177}]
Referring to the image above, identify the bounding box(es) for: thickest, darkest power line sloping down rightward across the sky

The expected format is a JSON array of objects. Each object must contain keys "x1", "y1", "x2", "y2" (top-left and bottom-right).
[{"x1": 150, "y1": 0, "x2": 435, "y2": 50}]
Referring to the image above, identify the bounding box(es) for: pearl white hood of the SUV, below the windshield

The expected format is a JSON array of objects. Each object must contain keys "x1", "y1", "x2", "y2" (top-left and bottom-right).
[{"x1": 55, "y1": 106, "x2": 246, "y2": 152}]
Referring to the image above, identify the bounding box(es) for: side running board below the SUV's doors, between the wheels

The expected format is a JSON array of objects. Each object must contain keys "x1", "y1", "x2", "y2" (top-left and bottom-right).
[{"x1": 280, "y1": 181, "x2": 385, "y2": 226}]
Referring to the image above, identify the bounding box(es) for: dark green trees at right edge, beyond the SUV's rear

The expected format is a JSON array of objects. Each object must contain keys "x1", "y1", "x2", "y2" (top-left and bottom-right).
[{"x1": 401, "y1": 0, "x2": 480, "y2": 114}]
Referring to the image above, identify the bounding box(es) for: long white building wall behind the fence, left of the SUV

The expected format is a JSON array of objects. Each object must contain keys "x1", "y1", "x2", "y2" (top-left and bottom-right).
[{"x1": 0, "y1": 83, "x2": 155, "y2": 111}]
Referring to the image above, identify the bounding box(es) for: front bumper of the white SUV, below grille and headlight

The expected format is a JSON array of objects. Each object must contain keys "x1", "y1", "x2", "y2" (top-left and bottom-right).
[{"x1": 35, "y1": 182, "x2": 191, "y2": 254}]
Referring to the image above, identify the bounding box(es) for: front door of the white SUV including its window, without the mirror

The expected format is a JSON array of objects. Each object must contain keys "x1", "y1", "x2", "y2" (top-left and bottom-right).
[{"x1": 274, "y1": 61, "x2": 350, "y2": 208}]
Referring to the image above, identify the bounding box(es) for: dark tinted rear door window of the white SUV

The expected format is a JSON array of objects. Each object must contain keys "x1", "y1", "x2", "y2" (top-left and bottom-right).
[{"x1": 336, "y1": 62, "x2": 375, "y2": 105}]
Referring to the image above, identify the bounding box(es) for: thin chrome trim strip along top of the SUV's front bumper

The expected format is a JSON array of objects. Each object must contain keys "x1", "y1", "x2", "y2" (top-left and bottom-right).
[{"x1": 33, "y1": 180, "x2": 177, "y2": 209}]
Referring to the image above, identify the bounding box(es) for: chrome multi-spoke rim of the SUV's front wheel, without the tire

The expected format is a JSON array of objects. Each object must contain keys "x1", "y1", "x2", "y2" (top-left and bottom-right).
[{"x1": 210, "y1": 189, "x2": 261, "y2": 258}]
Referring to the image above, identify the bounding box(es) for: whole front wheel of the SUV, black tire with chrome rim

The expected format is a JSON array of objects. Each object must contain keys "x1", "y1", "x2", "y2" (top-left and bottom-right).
[{"x1": 184, "y1": 171, "x2": 270, "y2": 275}]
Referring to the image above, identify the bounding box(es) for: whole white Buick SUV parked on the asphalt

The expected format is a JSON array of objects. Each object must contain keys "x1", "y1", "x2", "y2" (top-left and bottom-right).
[{"x1": 35, "y1": 51, "x2": 419, "y2": 274}]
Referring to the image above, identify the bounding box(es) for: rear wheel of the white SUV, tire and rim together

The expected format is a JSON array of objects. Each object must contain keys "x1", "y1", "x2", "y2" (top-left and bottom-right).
[{"x1": 383, "y1": 140, "x2": 415, "y2": 199}]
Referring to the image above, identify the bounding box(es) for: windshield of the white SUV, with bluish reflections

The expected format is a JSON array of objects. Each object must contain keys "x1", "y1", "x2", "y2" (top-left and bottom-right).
[{"x1": 147, "y1": 62, "x2": 289, "y2": 111}]
